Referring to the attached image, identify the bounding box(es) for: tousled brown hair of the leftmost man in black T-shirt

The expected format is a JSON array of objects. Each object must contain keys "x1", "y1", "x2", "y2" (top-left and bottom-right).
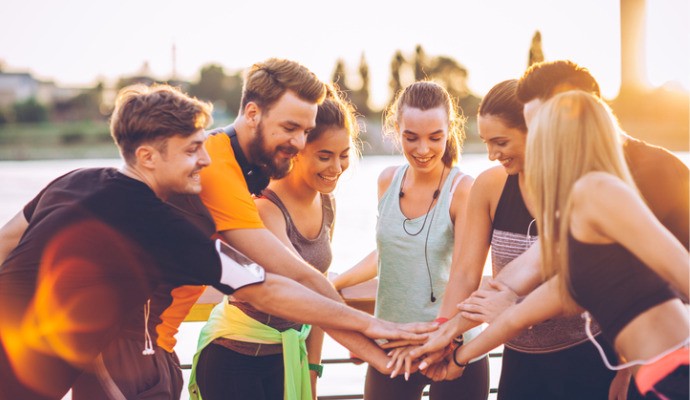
[{"x1": 110, "y1": 85, "x2": 213, "y2": 164}]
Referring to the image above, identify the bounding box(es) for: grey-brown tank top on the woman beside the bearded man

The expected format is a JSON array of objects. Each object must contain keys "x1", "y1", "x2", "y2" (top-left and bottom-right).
[{"x1": 213, "y1": 189, "x2": 335, "y2": 356}]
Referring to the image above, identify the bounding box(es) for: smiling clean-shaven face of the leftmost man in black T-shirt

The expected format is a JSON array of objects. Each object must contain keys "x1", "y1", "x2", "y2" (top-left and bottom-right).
[{"x1": 153, "y1": 129, "x2": 211, "y2": 198}]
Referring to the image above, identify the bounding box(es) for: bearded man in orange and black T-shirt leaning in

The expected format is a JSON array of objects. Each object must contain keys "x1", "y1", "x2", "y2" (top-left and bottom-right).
[{"x1": 159, "y1": 59, "x2": 414, "y2": 398}]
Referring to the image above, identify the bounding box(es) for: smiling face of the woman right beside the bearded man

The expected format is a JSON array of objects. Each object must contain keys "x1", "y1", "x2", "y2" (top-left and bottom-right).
[{"x1": 291, "y1": 127, "x2": 352, "y2": 193}]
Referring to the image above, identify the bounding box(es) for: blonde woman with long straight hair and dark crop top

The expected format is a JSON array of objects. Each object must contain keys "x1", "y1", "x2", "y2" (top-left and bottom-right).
[{"x1": 453, "y1": 91, "x2": 690, "y2": 399}]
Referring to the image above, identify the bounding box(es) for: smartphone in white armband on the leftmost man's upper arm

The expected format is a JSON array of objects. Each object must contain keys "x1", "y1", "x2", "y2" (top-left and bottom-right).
[{"x1": 216, "y1": 239, "x2": 266, "y2": 290}]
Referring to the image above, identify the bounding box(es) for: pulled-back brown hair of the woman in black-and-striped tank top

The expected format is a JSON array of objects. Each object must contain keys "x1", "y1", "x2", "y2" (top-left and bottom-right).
[{"x1": 478, "y1": 79, "x2": 527, "y2": 133}]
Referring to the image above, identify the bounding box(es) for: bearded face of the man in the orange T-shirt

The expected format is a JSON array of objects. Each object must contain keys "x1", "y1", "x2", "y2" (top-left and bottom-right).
[{"x1": 248, "y1": 91, "x2": 317, "y2": 179}]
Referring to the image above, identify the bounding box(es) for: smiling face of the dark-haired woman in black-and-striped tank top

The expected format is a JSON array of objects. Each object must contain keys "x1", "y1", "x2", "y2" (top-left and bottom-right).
[{"x1": 477, "y1": 115, "x2": 527, "y2": 175}]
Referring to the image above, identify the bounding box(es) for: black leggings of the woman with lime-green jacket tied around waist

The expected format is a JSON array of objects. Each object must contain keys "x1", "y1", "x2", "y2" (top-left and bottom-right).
[{"x1": 196, "y1": 343, "x2": 285, "y2": 400}]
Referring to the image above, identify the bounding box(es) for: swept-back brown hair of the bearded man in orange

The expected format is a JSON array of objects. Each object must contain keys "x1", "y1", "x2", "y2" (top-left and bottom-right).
[{"x1": 240, "y1": 58, "x2": 326, "y2": 114}]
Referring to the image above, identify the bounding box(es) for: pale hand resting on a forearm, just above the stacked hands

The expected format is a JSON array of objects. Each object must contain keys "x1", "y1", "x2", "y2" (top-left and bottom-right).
[{"x1": 458, "y1": 279, "x2": 518, "y2": 323}]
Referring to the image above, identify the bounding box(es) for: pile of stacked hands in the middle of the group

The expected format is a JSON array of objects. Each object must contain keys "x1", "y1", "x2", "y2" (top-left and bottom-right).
[{"x1": 380, "y1": 279, "x2": 518, "y2": 382}]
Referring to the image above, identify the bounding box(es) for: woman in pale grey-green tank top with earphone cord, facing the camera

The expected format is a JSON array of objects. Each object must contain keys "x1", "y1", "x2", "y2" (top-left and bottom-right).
[{"x1": 334, "y1": 82, "x2": 489, "y2": 400}]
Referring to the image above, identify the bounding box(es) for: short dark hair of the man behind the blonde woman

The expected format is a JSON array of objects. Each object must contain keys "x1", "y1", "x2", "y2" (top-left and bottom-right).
[{"x1": 516, "y1": 60, "x2": 601, "y2": 104}]
